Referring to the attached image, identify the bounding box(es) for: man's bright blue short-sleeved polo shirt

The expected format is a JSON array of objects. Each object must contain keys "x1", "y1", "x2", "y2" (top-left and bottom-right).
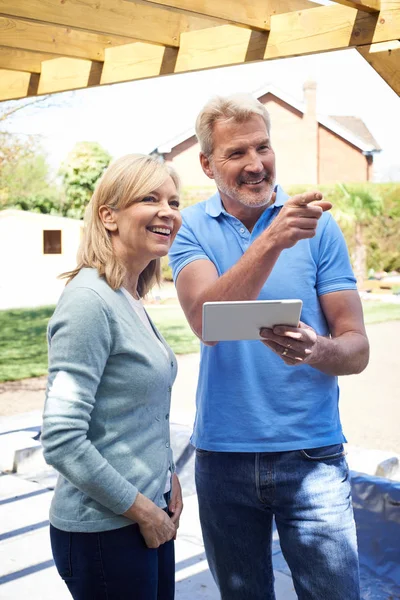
[{"x1": 170, "y1": 186, "x2": 356, "y2": 452}]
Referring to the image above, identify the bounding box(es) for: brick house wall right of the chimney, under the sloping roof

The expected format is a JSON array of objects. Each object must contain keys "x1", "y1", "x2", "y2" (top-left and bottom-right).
[{"x1": 318, "y1": 125, "x2": 371, "y2": 184}]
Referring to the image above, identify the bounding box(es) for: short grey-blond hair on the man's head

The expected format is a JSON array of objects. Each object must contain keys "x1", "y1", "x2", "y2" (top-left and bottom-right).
[{"x1": 196, "y1": 94, "x2": 271, "y2": 157}]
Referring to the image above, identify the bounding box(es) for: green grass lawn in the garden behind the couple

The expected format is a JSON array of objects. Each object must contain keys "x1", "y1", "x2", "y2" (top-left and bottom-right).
[{"x1": 0, "y1": 301, "x2": 400, "y2": 382}]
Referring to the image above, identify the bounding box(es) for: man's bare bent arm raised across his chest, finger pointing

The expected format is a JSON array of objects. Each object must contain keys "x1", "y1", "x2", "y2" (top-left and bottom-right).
[{"x1": 176, "y1": 192, "x2": 331, "y2": 345}]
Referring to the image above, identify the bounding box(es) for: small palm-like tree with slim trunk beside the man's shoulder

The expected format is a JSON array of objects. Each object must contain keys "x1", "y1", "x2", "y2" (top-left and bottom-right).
[{"x1": 335, "y1": 183, "x2": 383, "y2": 289}]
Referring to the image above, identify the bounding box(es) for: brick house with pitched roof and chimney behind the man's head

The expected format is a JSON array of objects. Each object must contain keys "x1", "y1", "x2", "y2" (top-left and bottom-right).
[{"x1": 152, "y1": 81, "x2": 381, "y2": 187}]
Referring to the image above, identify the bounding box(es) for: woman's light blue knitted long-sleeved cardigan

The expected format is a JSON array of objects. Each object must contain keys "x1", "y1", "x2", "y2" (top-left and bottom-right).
[{"x1": 42, "y1": 269, "x2": 177, "y2": 532}]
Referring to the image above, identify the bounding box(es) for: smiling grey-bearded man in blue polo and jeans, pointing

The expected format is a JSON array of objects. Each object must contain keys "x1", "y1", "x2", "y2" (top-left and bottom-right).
[{"x1": 170, "y1": 95, "x2": 369, "y2": 600}]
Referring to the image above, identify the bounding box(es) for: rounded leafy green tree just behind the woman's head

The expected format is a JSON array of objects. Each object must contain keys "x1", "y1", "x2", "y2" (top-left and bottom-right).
[{"x1": 59, "y1": 142, "x2": 111, "y2": 219}]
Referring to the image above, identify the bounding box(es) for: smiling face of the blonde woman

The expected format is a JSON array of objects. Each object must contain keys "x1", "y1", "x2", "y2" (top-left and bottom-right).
[{"x1": 107, "y1": 176, "x2": 182, "y2": 264}]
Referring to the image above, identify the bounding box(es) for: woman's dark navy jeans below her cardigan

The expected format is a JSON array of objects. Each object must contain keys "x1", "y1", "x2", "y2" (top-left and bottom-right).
[{"x1": 50, "y1": 524, "x2": 175, "y2": 600}]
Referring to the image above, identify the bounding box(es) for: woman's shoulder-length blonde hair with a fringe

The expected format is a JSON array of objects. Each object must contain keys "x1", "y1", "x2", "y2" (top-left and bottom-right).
[{"x1": 59, "y1": 154, "x2": 180, "y2": 297}]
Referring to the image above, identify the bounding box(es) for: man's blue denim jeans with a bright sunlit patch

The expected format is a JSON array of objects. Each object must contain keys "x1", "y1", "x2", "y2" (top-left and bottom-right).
[{"x1": 196, "y1": 444, "x2": 360, "y2": 600}]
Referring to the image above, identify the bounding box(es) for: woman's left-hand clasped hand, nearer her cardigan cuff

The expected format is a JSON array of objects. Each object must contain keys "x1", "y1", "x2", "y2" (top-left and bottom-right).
[{"x1": 124, "y1": 493, "x2": 176, "y2": 548}]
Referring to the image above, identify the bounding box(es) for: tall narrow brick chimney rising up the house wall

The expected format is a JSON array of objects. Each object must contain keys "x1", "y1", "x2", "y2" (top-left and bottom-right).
[{"x1": 302, "y1": 81, "x2": 319, "y2": 184}]
